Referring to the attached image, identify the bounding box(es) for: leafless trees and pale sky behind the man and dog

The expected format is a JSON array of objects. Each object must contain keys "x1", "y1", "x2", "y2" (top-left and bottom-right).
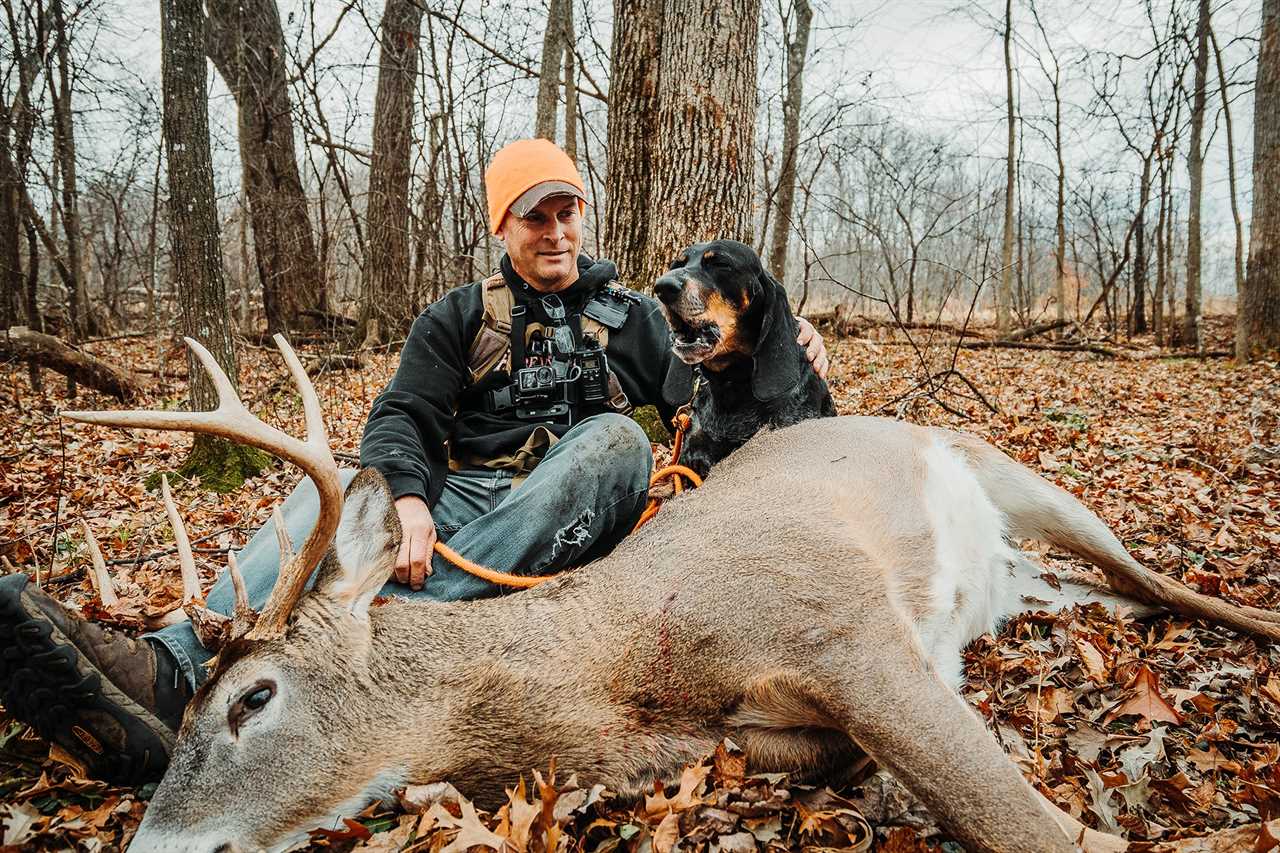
[{"x1": 0, "y1": 0, "x2": 1280, "y2": 368}]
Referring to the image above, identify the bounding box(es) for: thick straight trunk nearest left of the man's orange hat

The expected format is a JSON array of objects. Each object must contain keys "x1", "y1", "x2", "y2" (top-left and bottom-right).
[{"x1": 360, "y1": 0, "x2": 422, "y2": 343}]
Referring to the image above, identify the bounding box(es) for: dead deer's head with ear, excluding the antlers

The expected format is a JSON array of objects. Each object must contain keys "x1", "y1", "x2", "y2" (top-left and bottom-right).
[{"x1": 131, "y1": 470, "x2": 404, "y2": 852}]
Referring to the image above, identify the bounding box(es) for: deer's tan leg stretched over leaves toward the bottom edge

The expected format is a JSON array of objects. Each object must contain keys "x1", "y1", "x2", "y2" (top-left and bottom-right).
[{"x1": 814, "y1": 615, "x2": 1123, "y2": 853}]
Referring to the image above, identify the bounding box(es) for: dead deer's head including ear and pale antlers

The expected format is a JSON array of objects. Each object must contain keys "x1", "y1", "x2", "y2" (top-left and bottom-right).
[{"x1": 65, "y1": 336, "x2": 414, "y2": 852}]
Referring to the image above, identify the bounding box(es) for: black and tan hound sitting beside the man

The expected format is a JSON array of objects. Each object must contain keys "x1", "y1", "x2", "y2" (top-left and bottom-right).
[{"x1": 653, "y1": 240, "x2": 836, "y2": 475}]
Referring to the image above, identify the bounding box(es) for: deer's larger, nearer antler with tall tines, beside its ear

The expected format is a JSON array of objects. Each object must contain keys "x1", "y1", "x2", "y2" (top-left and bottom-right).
[{"x1": 63, "y1": 334, "x2": 342, "y2": 639}]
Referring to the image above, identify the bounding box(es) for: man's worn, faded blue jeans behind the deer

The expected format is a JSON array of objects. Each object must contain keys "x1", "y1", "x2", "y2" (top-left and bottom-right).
[{"x1": 147, "y1": 414, "x2": 653, "y2": 689}]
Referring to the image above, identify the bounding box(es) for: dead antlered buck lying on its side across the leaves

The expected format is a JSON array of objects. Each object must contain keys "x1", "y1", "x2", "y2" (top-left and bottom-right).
[{"x1": 67, "y1": 338, "x2": 1280, "y2": 852}]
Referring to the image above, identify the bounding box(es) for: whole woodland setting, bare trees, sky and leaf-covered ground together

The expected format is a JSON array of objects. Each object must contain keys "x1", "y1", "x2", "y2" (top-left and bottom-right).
[{"x1": 0, "y1": 0, "x2": 1280, "y2": 852}]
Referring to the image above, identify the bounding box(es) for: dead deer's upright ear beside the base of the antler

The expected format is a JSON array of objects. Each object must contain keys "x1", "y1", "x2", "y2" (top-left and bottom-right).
[{"x1": 316, "y1": 467, "x2": 401, "y2": 619}]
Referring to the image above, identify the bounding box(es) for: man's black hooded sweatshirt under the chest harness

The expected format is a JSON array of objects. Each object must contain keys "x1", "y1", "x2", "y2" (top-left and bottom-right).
[{"x1": 360, "y1": 255, "x2": 691, "y2": 507}]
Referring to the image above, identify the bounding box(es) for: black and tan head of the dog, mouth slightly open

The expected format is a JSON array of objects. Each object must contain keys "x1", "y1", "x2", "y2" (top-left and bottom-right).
[{"x1": 653, "y1": 240, "x2": 804, "y2": 401}]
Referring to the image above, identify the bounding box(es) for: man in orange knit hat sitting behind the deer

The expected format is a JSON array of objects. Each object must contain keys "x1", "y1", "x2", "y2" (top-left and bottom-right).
[{"x1": 0, "y1": 140, "x2": 826, "y2": 783}]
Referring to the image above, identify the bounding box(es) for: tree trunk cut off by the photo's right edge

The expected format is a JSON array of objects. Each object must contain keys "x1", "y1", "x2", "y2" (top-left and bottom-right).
[{"x1": 1236, "y1": 0, "x2": 1280, "y2": 361}]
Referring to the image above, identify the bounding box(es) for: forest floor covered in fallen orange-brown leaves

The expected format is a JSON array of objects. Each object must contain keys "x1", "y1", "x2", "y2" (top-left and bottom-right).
[{"x1": 0, "y1": 318, "x2": 1280, "y2": 853}]
